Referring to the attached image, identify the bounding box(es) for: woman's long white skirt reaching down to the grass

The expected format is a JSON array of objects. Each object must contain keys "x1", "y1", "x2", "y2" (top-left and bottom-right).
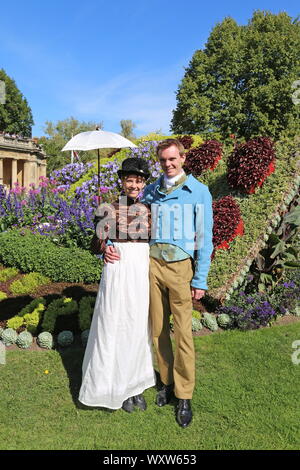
[{"x1": 79, "y1": 242, "x2": 155, "y2": 409}]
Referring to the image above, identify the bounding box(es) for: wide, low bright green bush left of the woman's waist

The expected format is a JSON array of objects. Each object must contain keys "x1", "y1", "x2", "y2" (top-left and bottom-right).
[{"x1": 0, "y1": 230, "x2": 101, "y2": 283}]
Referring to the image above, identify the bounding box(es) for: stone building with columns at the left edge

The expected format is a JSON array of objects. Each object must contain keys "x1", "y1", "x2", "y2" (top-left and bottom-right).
[{"x1": 0, "y1": 134, "x2": 47, "y2": 188}]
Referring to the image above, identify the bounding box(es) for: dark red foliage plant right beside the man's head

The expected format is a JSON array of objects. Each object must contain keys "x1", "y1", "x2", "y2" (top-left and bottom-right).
[{"x1": 184, "y1": 140, "x2": 222, "y2": 176}]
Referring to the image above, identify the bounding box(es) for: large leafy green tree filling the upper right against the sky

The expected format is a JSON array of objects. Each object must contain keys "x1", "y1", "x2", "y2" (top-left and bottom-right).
[{"x1": 171, "y1": 10, "x2": 300, "y2": 138}]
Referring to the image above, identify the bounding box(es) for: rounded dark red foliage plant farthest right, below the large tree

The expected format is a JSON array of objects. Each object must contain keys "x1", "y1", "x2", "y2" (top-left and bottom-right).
[{"x1": 227, "y1": 137, "x2": 275, "y2": 194}]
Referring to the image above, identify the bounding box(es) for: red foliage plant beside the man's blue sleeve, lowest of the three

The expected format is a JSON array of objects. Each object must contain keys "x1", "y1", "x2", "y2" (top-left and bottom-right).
[{"x1": 213, "y1": 196, "x2": 244, "y2": 260}]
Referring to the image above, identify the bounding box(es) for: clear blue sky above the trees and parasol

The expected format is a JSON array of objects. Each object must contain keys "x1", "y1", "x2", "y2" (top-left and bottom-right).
[{"x1": 0, "y1": 0, "x2": 300, "y2": 136}]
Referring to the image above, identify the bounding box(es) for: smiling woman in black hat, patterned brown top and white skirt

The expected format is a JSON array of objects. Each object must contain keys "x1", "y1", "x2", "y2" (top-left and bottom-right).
[{"x1": 79, "y1": 158, "x2": 155, "y2": 413}]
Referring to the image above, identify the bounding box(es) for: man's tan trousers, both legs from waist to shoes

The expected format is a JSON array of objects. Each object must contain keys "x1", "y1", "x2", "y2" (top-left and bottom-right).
[{"x1": 150, "y1": 258, "x2": 195, "y2": 399}]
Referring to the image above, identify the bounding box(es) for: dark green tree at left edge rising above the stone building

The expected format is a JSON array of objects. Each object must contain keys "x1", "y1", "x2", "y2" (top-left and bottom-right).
[{"x1": 0, "y1": 69, "x2": 34, "y2": 137}]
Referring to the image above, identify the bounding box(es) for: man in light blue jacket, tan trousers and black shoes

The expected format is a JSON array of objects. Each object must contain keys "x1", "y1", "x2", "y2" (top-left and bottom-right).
[{"x1": 105, "y1": 139, "x2": 213, "y2": 428}]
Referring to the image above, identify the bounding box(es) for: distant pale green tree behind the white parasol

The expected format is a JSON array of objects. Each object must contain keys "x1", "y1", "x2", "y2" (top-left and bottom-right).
[{"x1": 39, "y1": 117, "x2": 103, "y2": 173}]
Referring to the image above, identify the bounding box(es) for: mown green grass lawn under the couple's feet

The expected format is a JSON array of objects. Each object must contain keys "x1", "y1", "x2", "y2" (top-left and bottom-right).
[{"x1": 0, "y1": 322, "x2": 300, "y2": 450}]
